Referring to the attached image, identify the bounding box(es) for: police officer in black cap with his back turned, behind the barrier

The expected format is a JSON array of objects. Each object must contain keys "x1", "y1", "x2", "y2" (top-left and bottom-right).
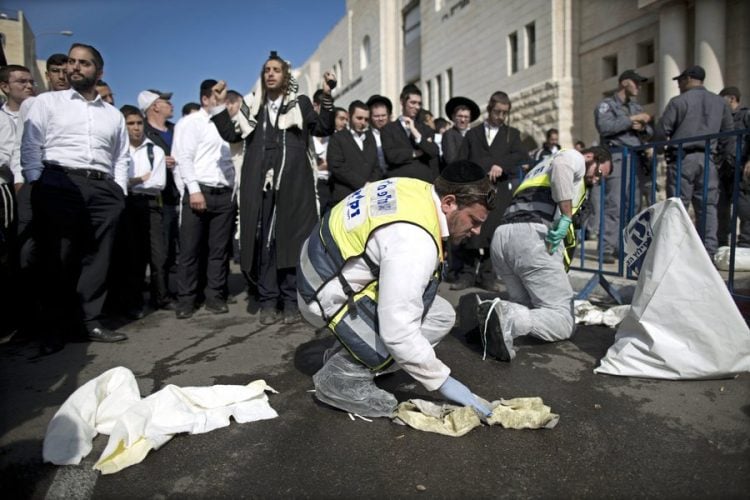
[{"x1": 656, "y1": 66, "x2": 735, "y2": 257}]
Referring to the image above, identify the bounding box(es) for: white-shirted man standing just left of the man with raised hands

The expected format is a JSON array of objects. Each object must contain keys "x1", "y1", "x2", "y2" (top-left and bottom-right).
[{"x1": 172, "y1": 80, "x2": 236, "y2": 319}]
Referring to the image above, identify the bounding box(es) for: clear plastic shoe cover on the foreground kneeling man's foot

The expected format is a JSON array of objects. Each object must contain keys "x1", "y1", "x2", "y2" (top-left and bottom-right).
[{"x1": 313, "y1": 351, "x2": 398, "y2": 417}]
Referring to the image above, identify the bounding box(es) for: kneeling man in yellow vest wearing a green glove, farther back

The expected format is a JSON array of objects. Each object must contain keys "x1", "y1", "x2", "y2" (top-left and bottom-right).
[{"x1": 478, "y1": 146, "x2": 612, "y2": 361}]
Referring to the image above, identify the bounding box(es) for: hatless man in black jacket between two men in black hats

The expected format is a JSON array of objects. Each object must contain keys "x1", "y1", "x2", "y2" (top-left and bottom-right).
[{"x1": 380, "y1": 84, "x2": 440, "y2": 182}]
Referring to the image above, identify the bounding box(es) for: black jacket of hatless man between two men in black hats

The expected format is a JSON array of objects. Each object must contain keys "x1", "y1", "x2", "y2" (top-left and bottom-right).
[{"x1": 380, "y1": 120, "x2": 440, "y2": 182}]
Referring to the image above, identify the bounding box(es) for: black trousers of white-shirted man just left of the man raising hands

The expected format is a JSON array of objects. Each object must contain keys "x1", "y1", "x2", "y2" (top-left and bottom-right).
[{"x1": 177, "y1": 186, "x2": 236, "y2": 308}]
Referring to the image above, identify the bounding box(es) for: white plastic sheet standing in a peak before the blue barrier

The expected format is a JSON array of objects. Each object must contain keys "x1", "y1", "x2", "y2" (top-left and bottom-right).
[{"x1": 594, "y1": 198, "x2": 750, "y2": 380}]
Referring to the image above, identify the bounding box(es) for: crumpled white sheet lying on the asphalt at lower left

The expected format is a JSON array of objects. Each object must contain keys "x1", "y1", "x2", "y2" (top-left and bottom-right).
[{"x1": 42, "y1": 367, "x2": 278, "y2": 474}]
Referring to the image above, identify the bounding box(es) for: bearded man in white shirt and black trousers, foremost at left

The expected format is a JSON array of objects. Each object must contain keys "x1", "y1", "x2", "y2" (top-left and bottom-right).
[{"x1": 21, "y1": 44, "x2": 129, "y2": 350}]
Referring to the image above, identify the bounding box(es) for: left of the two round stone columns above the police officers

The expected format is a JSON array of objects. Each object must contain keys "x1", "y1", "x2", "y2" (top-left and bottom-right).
[{"x1": 656, "y1": 2, "x2": 687, "y2": 113}]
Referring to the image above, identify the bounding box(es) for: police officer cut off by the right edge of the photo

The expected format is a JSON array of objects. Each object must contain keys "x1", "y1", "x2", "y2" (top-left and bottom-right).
[{"x1": 718, "y1": 87, "x2": 750, "y2": 247}]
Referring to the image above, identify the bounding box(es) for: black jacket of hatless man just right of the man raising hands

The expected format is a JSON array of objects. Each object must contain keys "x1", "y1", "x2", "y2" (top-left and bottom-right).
[{"x1": 326, "y1": 128, "x2": 381, "y2": 204}]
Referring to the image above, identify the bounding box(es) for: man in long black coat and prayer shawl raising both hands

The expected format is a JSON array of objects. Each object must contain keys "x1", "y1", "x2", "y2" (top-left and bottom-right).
[{"x1": 207, "y1": 51, "x2": 336, "y2": 325}]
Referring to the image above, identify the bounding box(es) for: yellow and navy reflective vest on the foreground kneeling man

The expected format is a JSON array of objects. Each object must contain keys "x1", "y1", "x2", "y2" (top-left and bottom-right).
[{"x1": 297, "y1": 178, "x2": 443, "y2": 370}]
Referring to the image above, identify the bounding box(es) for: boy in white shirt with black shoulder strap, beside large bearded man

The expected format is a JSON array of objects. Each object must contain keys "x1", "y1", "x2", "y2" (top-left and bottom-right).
[{"x1": 110, "y1": 105, "x2": 167, "y2": 319}]
